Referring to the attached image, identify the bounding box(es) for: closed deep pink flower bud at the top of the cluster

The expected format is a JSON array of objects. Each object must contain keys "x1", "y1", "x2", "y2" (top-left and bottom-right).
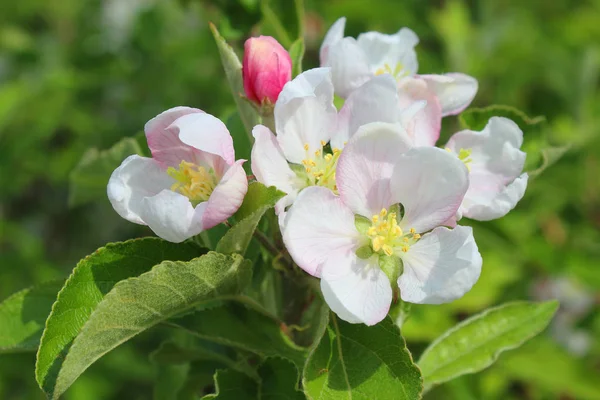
[{"x1": 242, "y1": 36, "x2": 292, "y2": 105}]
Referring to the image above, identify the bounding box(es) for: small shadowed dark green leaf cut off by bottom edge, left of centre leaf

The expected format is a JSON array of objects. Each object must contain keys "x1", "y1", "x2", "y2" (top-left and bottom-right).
[{"x1": 258, "y1": 358, "x2": 306, "y2": 400}]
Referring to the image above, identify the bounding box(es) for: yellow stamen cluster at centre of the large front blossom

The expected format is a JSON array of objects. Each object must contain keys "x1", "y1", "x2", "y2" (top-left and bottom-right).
[{"x1": 367, "y1": 208, "x2": 421, "y2": 256}]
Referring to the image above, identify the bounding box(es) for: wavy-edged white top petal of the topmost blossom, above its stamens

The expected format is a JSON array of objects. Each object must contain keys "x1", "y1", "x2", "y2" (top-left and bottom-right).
[{"x1": 357, "y1": 28, "x2": 419, "y2": 75}]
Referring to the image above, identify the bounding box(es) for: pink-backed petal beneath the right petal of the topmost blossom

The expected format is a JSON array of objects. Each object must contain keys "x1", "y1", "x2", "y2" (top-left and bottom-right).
[{"x1": 398, "y1": 77, "x2": 442, "y2": 146}]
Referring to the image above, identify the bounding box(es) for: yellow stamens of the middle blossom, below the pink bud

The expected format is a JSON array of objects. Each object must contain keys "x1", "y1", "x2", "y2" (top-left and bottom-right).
[{"x1": 302, "y1": 141, "x2": 342, "y2": 193}]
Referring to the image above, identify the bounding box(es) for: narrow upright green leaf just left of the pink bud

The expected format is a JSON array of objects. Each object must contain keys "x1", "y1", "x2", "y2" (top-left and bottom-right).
[{"x1": 210, "y1": 23, "x2": 259, "y2": 143}]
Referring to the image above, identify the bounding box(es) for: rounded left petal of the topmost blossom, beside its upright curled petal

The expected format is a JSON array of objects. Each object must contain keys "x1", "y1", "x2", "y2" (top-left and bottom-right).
[{"x1": 322, "y1": 37, "x2": 373, "y2": 98}]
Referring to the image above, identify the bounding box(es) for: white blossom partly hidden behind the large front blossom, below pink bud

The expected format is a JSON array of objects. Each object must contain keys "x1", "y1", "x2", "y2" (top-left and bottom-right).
[{"x1": 251, "y1": 68, "x2": 426, "y2": 214}]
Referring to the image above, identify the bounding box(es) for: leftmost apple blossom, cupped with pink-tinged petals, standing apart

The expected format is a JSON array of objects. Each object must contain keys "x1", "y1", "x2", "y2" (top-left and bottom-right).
[{"x1": 107, "y1": 107, "x2": 248, "y2": 243}]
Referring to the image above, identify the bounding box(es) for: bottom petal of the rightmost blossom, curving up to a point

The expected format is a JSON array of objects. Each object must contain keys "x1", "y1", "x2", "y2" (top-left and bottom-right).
[{"x1": 460, "y1": 173, "x2": 528, "y2": 221}]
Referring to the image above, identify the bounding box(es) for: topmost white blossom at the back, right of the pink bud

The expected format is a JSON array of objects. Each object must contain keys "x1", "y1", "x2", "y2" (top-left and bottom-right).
[{"x1": 320, "y1": 18, "x2": 477, "y2": 118}]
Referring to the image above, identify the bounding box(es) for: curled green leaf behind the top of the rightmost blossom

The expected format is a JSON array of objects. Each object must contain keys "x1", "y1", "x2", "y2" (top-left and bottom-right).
[{"x1": 459, "y1": 105, "x2": 570, "y2": 177}]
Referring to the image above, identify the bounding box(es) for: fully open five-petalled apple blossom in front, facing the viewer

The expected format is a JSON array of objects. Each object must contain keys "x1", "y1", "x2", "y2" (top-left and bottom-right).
[{"x1": 282, "y1": 123, "x2": 482, "y2": 325}]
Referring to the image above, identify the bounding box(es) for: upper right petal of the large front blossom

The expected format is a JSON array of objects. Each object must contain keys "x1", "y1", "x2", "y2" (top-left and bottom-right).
[{"x1": 392, "y1": 147, "x2": 469, "y2": 232}]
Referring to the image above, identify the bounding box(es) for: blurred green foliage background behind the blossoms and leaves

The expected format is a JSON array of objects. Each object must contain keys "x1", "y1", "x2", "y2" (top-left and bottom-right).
[{"x1": 0, "y1": 0, "x2": 600, "y2": 400}]
